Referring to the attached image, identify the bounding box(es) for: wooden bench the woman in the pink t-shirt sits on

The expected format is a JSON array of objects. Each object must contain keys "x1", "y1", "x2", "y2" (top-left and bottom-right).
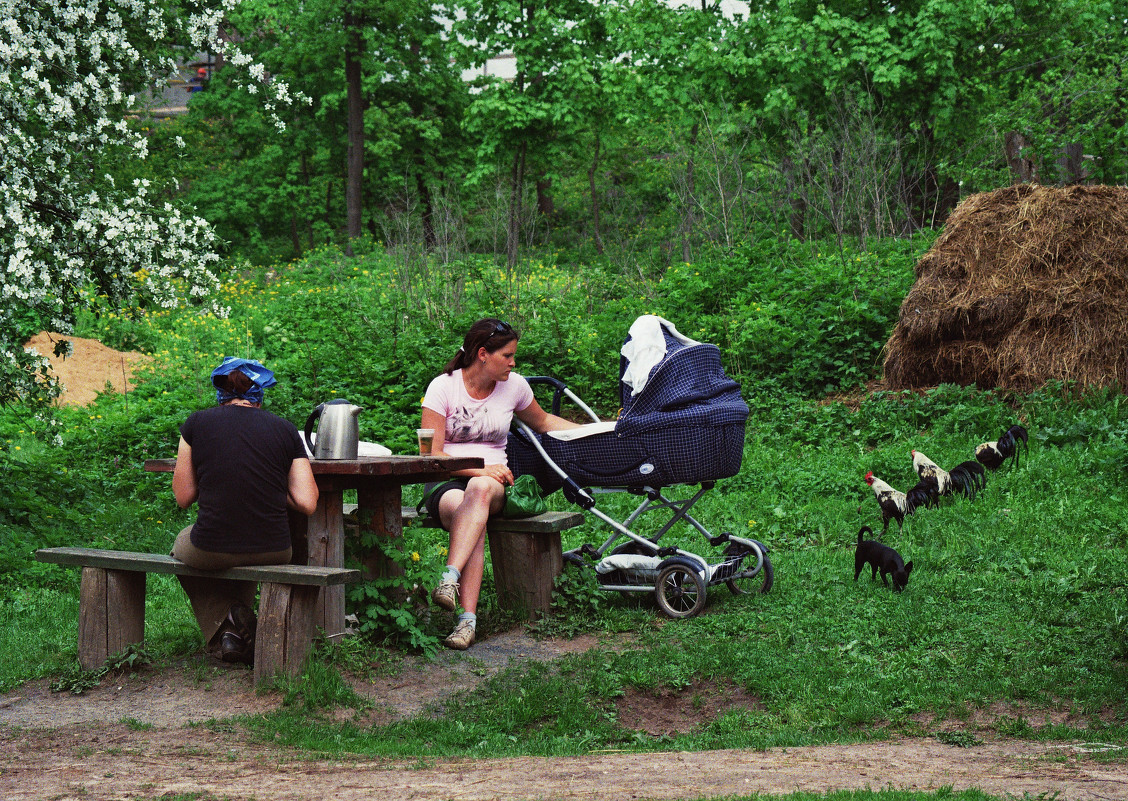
[{"x1": 345, "y1": 504, "x2": 584, "y2": 620}]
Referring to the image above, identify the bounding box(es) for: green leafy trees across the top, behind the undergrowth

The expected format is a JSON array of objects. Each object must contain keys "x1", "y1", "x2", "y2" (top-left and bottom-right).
[{"x1": 128, "y1": 0, "x2": 1128, "y2": 272}]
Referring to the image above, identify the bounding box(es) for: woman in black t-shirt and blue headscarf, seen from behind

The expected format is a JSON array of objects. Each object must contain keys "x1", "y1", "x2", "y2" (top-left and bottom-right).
[{"x1": 173, "y1": 357, "x2": 318, "y2": 664}]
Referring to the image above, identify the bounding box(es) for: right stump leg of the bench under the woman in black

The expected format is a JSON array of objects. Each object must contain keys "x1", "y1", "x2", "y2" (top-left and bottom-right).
[{"x1": 255, "y1": 581, "x2": 321, "y2": 684}]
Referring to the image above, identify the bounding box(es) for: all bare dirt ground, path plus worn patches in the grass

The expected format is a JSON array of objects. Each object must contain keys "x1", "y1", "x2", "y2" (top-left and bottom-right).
[{"x1": 0, "y1": 631, "x2": 1128, "y2": 801}]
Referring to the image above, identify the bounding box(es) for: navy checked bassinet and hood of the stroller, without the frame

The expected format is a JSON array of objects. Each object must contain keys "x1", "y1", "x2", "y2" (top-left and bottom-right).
[{"x1": 506, "y1": 318, "x2": 748, "y2": 494}]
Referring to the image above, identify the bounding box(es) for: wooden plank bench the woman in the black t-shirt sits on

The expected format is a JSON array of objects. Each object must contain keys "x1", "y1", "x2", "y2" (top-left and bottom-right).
[{"x1": 35, "y1": 548, "x2": 361, "y2": 683}]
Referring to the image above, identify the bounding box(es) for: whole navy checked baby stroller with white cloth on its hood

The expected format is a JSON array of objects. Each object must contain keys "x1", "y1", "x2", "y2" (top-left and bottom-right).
[{"x1": 506, "y1": 315, "x2": 773, "y2": 617}]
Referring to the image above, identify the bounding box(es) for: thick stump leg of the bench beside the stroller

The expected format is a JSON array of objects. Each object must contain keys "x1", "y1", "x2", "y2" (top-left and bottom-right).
[{"x1": 488, "y1": 531, "x2": 564, "y2": 620}]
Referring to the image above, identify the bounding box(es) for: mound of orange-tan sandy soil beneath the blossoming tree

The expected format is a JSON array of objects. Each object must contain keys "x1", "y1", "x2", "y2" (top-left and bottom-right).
[{"x1": 24, "y1": 331, "x2": 150, "y2": 406}]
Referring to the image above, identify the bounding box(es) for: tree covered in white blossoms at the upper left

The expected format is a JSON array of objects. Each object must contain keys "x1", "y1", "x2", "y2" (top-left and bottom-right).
[{"x1": 0, "y1": 0, "x2": 300, "y2": 403}]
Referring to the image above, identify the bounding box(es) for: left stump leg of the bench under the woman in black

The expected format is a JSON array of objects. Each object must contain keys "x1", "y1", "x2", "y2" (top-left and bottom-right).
[{"x1": 78, "y1": 567, "x2": 146, "y2": 670}]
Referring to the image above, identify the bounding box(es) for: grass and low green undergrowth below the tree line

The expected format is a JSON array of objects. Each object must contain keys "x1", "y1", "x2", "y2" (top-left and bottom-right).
[{"x1": 0, "y1": 239, "x2": 1128, "y2": 767}]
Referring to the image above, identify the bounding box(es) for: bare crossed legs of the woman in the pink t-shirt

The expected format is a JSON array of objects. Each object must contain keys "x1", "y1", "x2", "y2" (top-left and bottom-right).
[{"x1": 439, "y1": 476, "x2": 505, "y2": 614}]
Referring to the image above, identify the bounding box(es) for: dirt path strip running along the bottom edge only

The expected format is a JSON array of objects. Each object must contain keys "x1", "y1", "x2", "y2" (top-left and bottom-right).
[{"x1": 0, "y1": 724, "x2": 1128, "y2": 801}]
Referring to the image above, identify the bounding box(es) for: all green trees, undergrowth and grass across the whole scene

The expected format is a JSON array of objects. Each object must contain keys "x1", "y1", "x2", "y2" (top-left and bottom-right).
[{"x1": 0, "y1": 0, "x2": 1128, "y2": 752}]
